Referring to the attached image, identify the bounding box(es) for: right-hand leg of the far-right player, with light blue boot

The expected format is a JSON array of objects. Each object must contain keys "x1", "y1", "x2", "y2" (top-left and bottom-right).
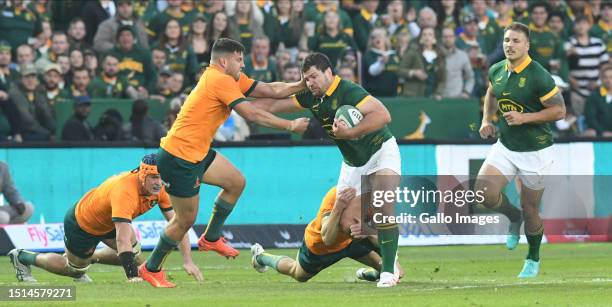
[{"x1": 518, "y1": 185, "x2": 544, "y2": 278}]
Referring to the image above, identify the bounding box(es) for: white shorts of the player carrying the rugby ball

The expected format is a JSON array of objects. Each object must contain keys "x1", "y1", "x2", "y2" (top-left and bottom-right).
[{"x1": 336, "y1": 137, "x2": 402, "y2": 195}]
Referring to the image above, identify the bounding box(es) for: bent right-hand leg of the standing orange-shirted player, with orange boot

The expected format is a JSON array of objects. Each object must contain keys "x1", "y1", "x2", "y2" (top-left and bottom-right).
[{"x1": 198, "y1": 153, "x2": 246, "y2": 258}]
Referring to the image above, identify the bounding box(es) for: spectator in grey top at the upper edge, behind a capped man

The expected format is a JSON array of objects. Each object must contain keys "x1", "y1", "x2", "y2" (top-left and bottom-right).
[{"x1": 93, "y1": 0, "x2": 149, "y2": 52}]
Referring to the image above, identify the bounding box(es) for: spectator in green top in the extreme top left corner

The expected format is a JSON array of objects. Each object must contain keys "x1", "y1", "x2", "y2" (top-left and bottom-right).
[{"x1": 0, "y1": 0, "x2": 42, "y2": 49}]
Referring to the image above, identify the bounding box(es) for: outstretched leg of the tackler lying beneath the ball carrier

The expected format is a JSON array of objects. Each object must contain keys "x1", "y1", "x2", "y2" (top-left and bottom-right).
[{"x1": 251, "y1": 243, "x2": 314, "y2": 282}]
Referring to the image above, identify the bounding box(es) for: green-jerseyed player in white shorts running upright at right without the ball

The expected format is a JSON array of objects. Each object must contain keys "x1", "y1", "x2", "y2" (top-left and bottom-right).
[{"x1": 476, "y1": 22, "x2": 565, "y2": 278}]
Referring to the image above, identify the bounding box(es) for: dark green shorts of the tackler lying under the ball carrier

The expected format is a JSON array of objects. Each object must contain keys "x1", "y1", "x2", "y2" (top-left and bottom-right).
[{"x1": 298, "y1": 240, "x2": 378, "y2": 275}]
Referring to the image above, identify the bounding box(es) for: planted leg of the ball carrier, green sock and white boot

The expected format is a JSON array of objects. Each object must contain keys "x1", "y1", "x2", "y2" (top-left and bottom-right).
[{"x1": 369, "y1": 169, "x2": 401, "y2": 288}]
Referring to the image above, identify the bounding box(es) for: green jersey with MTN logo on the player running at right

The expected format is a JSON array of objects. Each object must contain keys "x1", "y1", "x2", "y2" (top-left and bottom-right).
[{"x1": 489, "y1": 56, "x2": 559, "y2": 151}]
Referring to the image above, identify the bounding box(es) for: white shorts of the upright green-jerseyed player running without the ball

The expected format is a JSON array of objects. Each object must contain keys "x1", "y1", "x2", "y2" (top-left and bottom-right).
[{"x1": 484, "y1": 141, "x2": 553, "y2": 190}]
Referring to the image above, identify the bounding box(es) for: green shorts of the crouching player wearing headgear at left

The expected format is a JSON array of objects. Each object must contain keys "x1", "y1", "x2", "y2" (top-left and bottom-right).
[{"x1": 64, "y1": 205, "x2": 116, "y2": 259}]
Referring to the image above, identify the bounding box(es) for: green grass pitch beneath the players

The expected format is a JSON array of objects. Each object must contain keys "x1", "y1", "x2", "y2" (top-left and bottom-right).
[{"x1": 0, "y1": 243, "x2": 612, "y2": 307}]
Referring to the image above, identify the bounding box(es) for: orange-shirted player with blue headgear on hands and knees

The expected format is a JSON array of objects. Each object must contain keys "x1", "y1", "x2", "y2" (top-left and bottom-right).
[{"x1": 8, "y1": 154, "x2": 203, "y2": 282}]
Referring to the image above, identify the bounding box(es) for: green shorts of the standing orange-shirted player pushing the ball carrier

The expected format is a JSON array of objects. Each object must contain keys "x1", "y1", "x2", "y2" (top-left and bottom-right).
[{"x1": 157, "y1": 147, "x2": 217, "y2": 197}]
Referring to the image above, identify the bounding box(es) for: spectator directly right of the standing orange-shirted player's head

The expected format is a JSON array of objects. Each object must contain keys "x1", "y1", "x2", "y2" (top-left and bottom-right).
[{"x1": 244, "y1": 36, "x2": 278, "y2": 82}]
